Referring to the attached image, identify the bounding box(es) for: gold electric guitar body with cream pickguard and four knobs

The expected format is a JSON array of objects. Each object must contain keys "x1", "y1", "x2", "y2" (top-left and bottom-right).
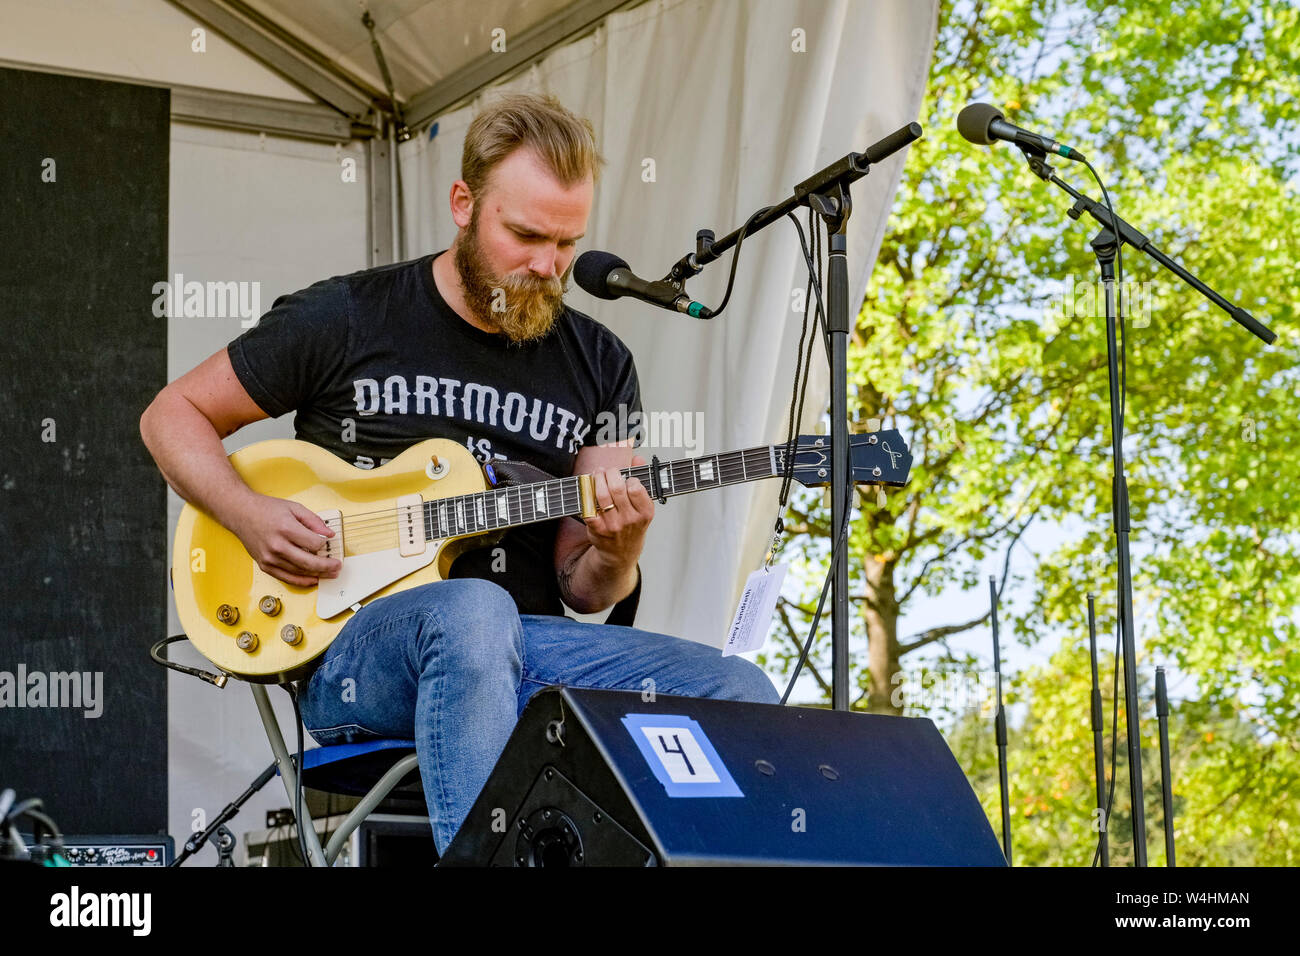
[{"x1": 172, "y1": 438, "x2": 494, "y2": 683}]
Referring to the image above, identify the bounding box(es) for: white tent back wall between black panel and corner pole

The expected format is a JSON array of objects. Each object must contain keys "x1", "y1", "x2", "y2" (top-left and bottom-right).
[{"x1": 162, "y1": 124, "x2": 367, "y2": 862}]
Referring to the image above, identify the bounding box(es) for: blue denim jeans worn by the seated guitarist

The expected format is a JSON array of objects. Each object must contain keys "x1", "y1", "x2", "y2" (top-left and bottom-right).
[{"x1": 302, "y1": 578, "x2": 780, "y2": 855}]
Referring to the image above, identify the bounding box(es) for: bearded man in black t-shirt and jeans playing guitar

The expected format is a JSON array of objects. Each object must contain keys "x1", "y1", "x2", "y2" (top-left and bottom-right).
[{"x1": 140, "y1": 95, "x2": 777, "y2": 853}]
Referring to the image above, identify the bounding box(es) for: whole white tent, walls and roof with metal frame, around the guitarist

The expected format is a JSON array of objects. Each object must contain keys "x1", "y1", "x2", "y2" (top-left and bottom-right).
[{"x1": 0, "y1": 0, "x2": 936, "y2": 858}]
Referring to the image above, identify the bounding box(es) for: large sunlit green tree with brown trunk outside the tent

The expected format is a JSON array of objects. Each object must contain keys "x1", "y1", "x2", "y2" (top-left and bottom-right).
[{"x1": 761, "y1": 0, "x2": 1300, "y2": 862}]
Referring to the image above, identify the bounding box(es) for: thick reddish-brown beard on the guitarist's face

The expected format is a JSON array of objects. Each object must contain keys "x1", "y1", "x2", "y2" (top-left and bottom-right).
[{"x1": 455, "y1": 209, "x2": 573, "y2": 345}]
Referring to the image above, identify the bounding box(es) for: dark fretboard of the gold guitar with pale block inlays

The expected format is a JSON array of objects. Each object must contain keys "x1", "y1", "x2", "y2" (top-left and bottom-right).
[{"x1": 424, "y1": 444, "x2": 787, "y2": 541}]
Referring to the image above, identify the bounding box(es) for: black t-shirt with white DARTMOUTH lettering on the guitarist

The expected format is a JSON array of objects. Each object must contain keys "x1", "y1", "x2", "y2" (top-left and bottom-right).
[{"x1": 228, "y1": 255, "x2": 641, "y2": 614}]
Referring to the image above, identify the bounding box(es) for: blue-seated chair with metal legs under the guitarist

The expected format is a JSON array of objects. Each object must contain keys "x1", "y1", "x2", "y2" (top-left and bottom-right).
[{"x1": 159, "y1": 566, "x2": 641, "y2": 866}]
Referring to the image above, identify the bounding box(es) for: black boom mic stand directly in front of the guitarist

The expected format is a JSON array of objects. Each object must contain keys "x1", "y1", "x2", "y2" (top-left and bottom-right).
[{"x1": 663, "y1": 122, "x2": 922, "y2": 710}]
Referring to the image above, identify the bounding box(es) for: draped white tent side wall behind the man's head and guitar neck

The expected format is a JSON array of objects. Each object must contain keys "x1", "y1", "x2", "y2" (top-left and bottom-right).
[{"x1": 399, "y1": 0, "x2": 937, "y2": 646}]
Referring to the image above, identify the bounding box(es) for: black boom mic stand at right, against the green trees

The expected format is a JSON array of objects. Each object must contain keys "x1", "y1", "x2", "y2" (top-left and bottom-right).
[{"x1": 1018, "y1": 143, "x2": 1277, "y2": 866}]
